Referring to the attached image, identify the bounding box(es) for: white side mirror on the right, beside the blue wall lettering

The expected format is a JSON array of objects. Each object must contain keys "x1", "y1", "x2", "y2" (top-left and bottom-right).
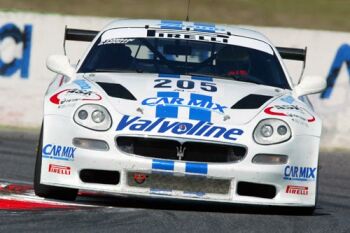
[{"x1": 293, "y1": 76, "x2": 327, "y2": 97}]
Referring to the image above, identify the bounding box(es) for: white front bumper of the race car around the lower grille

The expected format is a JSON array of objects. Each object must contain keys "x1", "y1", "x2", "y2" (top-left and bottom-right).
[{"x1": 41, "y1": 115, "x2": 319, "y2": 206}]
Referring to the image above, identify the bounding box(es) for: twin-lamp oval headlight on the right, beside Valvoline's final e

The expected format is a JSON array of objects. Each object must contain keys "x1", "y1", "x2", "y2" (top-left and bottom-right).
[{"x1": 253, "y1": 119, "x2": 292, "y2": 145}]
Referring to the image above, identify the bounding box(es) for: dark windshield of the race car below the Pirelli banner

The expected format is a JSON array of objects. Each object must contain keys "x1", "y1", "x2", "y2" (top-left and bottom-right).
[{"x1": 78, "y1": 38, "x2": 290, "y2": 89}]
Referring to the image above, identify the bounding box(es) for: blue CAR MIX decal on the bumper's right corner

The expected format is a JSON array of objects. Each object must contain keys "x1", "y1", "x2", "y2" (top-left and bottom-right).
[{"x1": 283, "y1": 165, "x2": 317, "y2": 181}]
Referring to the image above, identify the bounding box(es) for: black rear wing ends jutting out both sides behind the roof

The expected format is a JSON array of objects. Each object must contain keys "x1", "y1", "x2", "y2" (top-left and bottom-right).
[{"x1": 64, "y1": 27, "x2": 307, "y2": 62}]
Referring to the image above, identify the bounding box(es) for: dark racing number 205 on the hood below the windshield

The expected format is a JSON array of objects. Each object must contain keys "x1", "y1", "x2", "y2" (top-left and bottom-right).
[{"x1": 154, "y1": 79, "x2": 218, "y2": 92}]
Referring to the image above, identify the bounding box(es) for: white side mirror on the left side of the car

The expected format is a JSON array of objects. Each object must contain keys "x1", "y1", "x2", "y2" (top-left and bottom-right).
[{"x1": 46, "y1": 55, "x2": 76, "y2": 81}]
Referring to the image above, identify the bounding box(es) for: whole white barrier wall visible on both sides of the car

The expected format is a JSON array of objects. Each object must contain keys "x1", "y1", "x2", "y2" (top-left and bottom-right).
[{"x1": 0, "y1": 12, "x2": 350, "y2": 149}]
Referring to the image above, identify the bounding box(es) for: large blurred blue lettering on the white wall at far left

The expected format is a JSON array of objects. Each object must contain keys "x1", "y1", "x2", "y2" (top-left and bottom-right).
[{"x1": 0, "y1": 23, "x2": 32, "y2": 79}]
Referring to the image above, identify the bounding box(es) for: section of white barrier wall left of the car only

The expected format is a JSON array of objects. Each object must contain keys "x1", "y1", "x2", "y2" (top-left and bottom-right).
[{"x1": 0, "y1": 13, "x2": 110, "y2": 127}]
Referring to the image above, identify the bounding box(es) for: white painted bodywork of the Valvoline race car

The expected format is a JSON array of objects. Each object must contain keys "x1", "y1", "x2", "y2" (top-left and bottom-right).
[{"x1": 41, "y1": 20, "x2": 321, "y2": 207}]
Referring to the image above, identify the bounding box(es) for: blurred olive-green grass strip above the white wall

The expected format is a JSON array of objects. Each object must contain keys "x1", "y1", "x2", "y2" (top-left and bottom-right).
[{"x1": 0, "y1": 0, "x2": 350, "y2": 31}]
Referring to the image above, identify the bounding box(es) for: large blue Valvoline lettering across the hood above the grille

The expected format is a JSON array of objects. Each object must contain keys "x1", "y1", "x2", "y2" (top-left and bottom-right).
[{"x1": 116, "y1": 115, "x2": 243, "y2": 141}]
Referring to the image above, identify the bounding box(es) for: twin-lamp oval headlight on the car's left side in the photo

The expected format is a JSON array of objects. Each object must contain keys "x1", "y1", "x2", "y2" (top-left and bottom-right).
[{"x1": 74, "y1": 104, "x2": 112, "y2": 131}]
